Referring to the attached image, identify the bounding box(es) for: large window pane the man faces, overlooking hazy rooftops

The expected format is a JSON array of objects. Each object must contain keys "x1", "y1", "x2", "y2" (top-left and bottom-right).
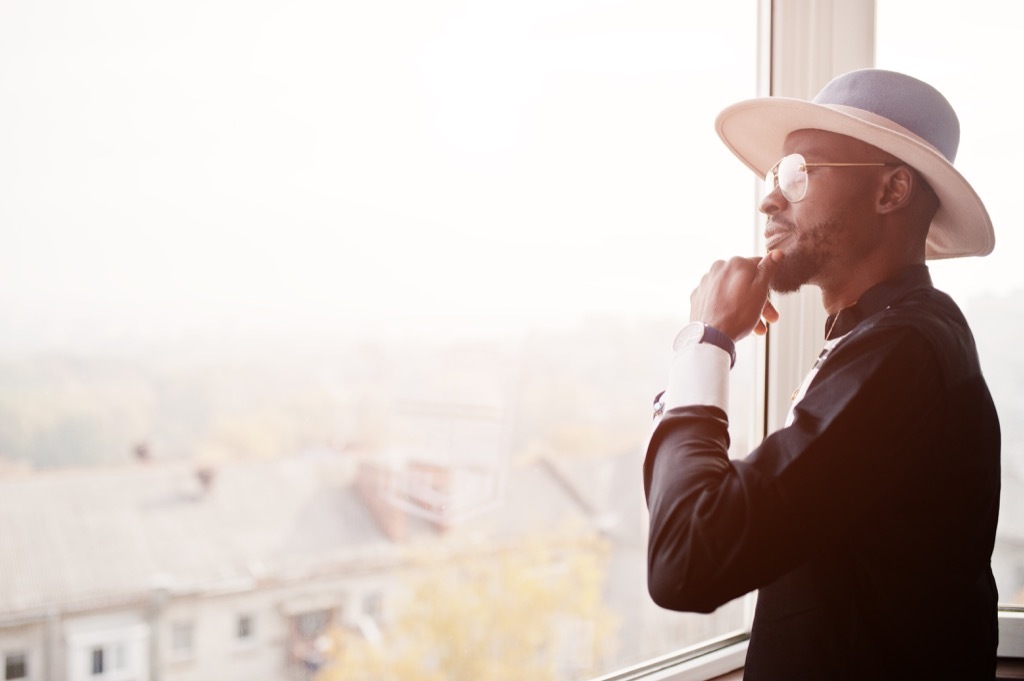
[{"x1": 0, "y1": 0, "x2": 759, "y2": 679}]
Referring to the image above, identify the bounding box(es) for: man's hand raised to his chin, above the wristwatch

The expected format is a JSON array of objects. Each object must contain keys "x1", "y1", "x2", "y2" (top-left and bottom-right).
[{"x1": 690, "y1": 251, "x2": 783, "y2": 341}]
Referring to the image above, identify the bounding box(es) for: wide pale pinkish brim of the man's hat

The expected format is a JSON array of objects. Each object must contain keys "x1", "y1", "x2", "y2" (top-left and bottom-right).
[{"x1": 715, "y1": 97, "x2": 995, "y2": 260}]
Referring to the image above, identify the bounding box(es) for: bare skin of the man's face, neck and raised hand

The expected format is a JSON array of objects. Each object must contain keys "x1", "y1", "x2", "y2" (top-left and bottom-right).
[{"x1": 690, "y1": 130, "x2": 938, "y2": 341}]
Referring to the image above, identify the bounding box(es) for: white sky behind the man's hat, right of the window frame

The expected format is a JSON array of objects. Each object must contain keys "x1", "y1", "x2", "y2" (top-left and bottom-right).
[{"x1": 876, "y1": 0, "x2": 1024, "y2": 305}]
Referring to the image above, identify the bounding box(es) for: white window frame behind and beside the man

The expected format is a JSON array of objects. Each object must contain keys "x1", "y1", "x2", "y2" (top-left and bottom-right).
[{"x1": 598, "y1": 0, "x2": 1024, "y2": 681}]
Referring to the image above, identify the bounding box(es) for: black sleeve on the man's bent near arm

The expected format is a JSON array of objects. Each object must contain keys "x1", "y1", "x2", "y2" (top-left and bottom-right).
[{"x1": 643, "y1": 329, "x2": 942, "y2": 612}]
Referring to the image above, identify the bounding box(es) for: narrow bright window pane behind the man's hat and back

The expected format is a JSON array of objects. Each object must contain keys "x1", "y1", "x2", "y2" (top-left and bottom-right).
[{"x1": 877, "y1": 0, "x2": 1024, "y2": 605}]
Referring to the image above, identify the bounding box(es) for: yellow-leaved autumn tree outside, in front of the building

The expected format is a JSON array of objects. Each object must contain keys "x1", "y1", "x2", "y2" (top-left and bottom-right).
[{"x1": 316, "y1": 535, "x2": 614, "y2": 681}]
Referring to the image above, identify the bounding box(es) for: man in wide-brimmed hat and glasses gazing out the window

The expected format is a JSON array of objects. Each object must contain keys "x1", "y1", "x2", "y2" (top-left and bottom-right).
[{"x1": 644, "y1": 70, "x2": 999, "y2": 681}]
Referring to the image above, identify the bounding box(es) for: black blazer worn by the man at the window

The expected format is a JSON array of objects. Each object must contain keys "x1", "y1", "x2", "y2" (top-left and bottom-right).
[{"x1": 644, "y1": 265, "x2": 999, "y2": 681}]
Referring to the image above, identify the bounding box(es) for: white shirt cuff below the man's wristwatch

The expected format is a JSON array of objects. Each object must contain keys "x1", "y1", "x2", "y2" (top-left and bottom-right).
[{"x1": 662, "y1": 343, "x2": 732, "y2": 412}]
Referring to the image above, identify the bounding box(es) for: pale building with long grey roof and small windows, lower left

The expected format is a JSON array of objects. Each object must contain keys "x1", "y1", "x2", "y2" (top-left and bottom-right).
[{"x1": 0, "y1": 446, "x2": 643, "y2": 681}]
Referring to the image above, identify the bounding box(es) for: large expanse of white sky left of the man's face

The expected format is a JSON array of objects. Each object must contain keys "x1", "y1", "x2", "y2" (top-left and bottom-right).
[{"x1": 0, "y1": 0, "x2": 756, "y2": 347}]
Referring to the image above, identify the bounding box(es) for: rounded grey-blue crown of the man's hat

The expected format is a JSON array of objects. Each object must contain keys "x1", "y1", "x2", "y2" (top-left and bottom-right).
[{"x1": 813, "y1": 69, "x2": 959, "y2": 163}]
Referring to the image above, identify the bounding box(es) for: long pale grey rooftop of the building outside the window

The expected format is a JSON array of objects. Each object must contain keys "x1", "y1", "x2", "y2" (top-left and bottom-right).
[{"x1": 0, "y1": 453, "x2": 606, "y2": 616}]
